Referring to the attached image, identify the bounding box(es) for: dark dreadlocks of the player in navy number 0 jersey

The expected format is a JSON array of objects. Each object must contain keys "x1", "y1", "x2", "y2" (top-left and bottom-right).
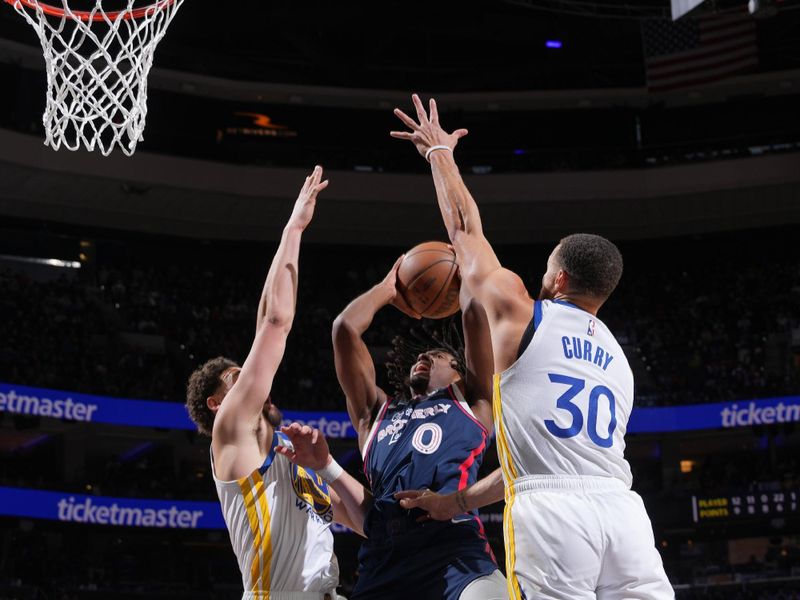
[{"x1": 385, "y1": 318, "x2": 467, "y2": 400}]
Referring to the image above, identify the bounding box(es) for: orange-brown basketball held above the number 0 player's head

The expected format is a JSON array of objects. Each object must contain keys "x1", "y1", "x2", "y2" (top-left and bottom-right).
[{"x1": 397, "y1": 242, "x2": 461, "y2": 319}]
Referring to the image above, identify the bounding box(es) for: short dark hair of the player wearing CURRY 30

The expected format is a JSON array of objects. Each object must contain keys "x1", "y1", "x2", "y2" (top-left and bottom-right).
[{"x1": 558, "y1": 233, "x2": 622, "y2": 301}]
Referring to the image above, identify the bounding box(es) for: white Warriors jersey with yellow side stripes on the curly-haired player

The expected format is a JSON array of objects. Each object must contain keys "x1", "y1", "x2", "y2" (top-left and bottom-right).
[{"x1": 211, "y1": 432, "x2": 339, "y2": 599}]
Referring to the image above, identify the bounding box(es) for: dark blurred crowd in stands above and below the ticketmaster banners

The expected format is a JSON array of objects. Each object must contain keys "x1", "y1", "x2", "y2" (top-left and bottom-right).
[{"x1": 0, "y1": 231, "x2": 800, "y2": 600}]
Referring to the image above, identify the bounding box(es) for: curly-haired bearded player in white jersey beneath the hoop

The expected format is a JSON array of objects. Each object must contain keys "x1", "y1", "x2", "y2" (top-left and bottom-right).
[{"x1": 186, "y1": 167, "x2": 364, "y2": 600}]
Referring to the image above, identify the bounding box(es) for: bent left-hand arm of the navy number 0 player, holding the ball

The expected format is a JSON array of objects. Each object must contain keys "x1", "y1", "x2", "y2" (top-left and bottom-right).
[{"x1": 332, "y1": 256, "x2": 419, "y2": 449}]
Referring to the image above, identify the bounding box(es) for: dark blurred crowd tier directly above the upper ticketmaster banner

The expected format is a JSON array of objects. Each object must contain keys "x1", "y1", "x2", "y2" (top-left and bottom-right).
[{"x1": 0, "y1": 227, "x2": 800, "y2": 410}]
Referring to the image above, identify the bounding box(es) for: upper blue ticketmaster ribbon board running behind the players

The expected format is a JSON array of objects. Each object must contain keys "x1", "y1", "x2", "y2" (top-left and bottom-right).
[{"x1": 0, "y1": 383, "x2": 800, "y2": 438}]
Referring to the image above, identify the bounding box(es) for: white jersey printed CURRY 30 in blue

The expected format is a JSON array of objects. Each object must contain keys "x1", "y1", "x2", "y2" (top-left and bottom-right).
[{"x1": 493, "y1": 300, "x2": 633, "y2": 487}]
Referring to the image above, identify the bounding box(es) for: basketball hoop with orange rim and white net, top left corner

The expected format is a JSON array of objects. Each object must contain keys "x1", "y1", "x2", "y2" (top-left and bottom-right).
[{"x1": 5, "y1": 0, "x2": 184, "y2": 156}]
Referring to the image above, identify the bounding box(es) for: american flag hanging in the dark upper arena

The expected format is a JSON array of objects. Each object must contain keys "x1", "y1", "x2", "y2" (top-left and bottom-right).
[{"x1": 642, "y1": 12, "x2": 758, "y2": 92}]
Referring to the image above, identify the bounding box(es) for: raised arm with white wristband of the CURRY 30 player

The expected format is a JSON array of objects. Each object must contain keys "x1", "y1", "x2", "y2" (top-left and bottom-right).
[{"x1": 390, "y1": 94, "x2": 533, "y2": 371}]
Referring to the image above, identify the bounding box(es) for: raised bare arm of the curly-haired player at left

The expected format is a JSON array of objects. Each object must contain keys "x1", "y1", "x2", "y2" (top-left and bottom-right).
[{"x1": 212, "y1": 167, "x2": 328, "y2": 442}]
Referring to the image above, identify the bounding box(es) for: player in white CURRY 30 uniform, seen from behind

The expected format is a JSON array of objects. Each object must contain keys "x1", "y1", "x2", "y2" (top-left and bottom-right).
[{"x1": 391, "y1": 95, "x2": 674, "y2": 600}]
